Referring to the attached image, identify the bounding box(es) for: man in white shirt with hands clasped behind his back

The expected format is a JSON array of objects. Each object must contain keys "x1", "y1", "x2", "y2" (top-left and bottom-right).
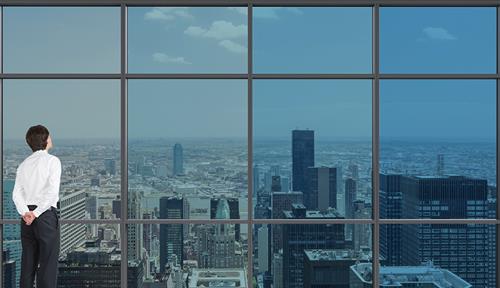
[{"x1": 12, "y1": 125, "x2": 61, "y2": 288}]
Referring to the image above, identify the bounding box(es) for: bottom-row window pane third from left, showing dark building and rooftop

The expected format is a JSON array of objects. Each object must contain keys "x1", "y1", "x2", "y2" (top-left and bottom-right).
[{"x1": 253, "y1": 224, "x2": 372, "y2": 288}]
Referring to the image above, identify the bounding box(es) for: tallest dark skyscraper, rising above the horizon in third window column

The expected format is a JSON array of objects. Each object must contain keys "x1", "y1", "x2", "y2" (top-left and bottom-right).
[{"x1": 292, "y1": 130, "x2": 314, "y2": 192}]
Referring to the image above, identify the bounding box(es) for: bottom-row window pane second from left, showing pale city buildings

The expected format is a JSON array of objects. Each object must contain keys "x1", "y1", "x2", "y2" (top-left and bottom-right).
[{"x1": 128, "y1": 223, "x2": 250, "y2": 287}]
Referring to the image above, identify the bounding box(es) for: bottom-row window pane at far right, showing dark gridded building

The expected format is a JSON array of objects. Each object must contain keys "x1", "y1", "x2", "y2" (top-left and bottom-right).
[{"x1": 378, "y1": 224, "x2": 497, "y2": 287}]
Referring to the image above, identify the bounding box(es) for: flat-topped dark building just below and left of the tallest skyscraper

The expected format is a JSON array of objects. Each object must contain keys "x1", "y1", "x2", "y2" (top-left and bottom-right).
[{"x1": 271, "y1": 192, "x2": 304, "y2": 253}]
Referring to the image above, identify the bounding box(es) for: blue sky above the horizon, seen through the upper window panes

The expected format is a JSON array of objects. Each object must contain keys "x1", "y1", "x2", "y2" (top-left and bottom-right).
[{"x1": 4, "y1": 7, "x2": 496, "y2": 139}]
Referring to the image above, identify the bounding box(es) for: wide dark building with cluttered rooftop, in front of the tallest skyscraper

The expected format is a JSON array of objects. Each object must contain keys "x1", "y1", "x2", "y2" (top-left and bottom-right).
[{"x1": 281, "y1": 204, "x2": 345, "y2": 288}]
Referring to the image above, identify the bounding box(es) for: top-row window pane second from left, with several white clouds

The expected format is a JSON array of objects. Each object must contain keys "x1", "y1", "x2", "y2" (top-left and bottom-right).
[{"x1": 128, "y1": 7, "x2": 248, "y2": 73}]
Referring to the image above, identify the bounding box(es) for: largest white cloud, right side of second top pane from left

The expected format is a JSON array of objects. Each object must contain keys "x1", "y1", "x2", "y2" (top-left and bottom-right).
[{"x1": 184, "y1": 20, "x2": 247, "y2": 40}]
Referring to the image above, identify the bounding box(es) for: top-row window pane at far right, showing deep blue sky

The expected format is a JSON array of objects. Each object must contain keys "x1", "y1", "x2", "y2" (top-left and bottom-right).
[{"x1": 380, "y1": 7, "x2": 497, "y2": 73}]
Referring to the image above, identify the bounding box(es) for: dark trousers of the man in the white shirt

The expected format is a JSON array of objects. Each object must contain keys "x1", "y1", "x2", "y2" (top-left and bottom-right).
[{"x1": 19, "y1": 205, "x2": 60, "y2": 288}]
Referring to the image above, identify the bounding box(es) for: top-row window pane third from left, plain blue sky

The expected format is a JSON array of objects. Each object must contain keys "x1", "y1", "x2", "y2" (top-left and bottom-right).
[{"x1": 253, "y1": 7, "x2": 372, "y2": 73}]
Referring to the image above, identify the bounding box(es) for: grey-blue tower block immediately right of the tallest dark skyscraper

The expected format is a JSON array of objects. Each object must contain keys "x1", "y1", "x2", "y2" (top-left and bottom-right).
[{"x1": 303, "y1": 167, "x2": 338, "y2": 211}]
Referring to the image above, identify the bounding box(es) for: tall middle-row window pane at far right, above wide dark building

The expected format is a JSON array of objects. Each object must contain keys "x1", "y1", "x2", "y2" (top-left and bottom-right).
[{"x1": 380, "y1": 80, "x2": 497, "y2": 218}]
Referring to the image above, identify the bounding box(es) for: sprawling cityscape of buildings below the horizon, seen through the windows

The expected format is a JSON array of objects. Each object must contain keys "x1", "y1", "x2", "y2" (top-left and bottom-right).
[{"x1": 3, "y1": 129, "x2": 496, "y2": 288}]
